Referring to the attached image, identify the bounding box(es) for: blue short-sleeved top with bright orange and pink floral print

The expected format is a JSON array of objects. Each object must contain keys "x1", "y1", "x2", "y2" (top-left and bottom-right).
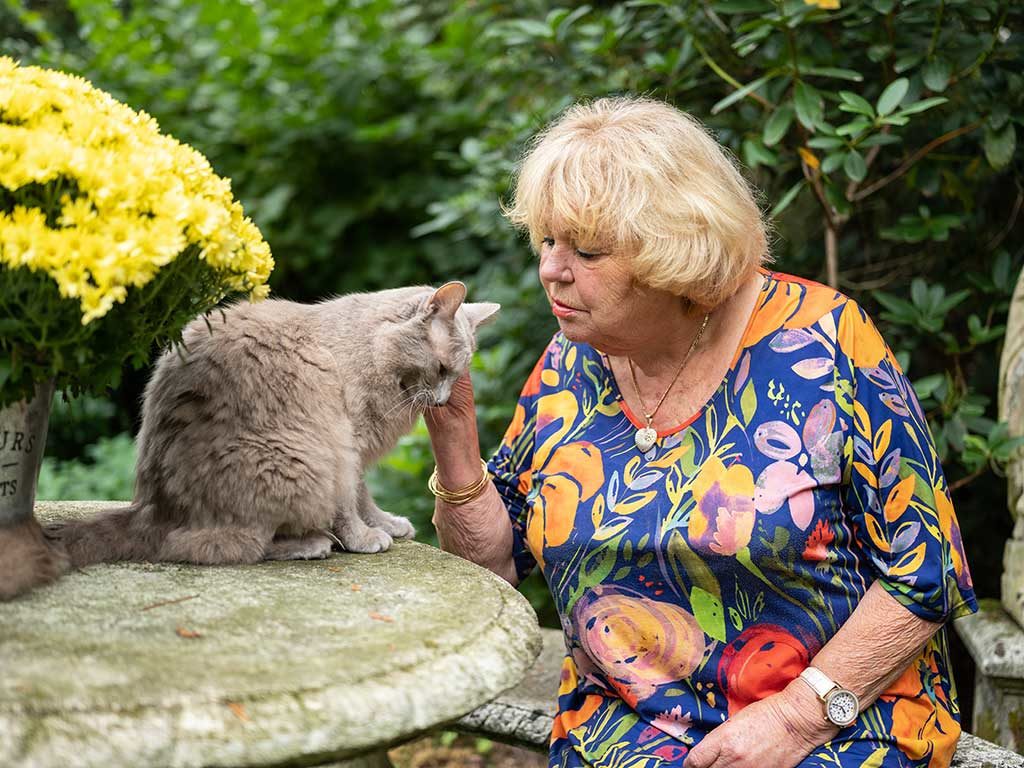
[{"x1": 489, "y1": 271, "x2": 977, "y2": 768}]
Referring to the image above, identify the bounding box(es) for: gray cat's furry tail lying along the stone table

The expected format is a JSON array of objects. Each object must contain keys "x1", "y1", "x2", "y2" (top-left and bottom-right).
[{"x1": 45, "y1": 504, "x2": 164, "y2": 568}]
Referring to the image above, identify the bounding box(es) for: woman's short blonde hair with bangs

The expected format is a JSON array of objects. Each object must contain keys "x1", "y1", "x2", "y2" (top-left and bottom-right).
[{"x1": 505, "y1": 96, "x2": 770, "y2": 306}]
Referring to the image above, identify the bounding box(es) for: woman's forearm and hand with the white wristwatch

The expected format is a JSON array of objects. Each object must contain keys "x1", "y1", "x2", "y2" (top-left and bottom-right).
[{"x1": 686, "y1": 582, "x2": 942, "y2": 768}]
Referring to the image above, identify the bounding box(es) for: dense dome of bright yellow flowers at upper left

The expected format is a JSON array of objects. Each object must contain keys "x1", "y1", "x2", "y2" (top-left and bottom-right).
[{"x1": 0, "y1": 56, "x2": 273, "y2": 325}]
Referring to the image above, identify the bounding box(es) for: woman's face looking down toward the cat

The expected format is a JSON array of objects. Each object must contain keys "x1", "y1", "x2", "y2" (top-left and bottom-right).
[{"x1": 540, "y1": 222, "x2": 681, "y2": 354}]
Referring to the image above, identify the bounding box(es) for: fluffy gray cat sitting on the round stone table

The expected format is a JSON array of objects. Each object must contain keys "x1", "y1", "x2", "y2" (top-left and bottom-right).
[{"x1": 47, "y1": 283, "x2": 499, "y2": 566}]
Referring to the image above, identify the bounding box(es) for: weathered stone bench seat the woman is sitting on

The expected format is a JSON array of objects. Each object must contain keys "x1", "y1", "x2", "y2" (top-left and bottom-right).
[{"x1": 466, "y1": 620, "x2": 1024, "y2": 768}]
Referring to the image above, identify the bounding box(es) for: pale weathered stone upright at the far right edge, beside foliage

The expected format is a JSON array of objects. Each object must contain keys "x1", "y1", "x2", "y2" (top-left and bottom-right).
[{"x1": 999, "y1": 268, "x2": 1024, "y2": 627}]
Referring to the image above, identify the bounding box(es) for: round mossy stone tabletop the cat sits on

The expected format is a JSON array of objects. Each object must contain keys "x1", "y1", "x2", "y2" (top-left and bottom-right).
[{"x1": 0, "y1": 503, "x2": 541, "y2": 768}]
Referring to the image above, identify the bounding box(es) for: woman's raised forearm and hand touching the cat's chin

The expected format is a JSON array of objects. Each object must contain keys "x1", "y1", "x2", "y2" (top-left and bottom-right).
[{"x1": 424, "y1": 373, "x2": 517, "y2": 586}]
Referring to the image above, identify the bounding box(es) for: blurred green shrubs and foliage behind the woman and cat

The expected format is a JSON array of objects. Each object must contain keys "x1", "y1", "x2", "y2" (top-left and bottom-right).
[{"x1": 0, "y1": 0, "x2": 1024, "y2": 716}]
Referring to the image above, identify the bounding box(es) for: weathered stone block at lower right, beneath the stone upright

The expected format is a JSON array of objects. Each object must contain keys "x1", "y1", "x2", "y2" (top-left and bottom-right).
[{"x1": 953, "y1": 600, "x2": 1024, "y2": 752}]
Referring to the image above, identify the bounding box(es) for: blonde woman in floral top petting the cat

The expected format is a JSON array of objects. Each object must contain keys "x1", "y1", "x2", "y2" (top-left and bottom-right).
[{"x1": 428, "y1": 98, "x2": 977, "y2": 768}]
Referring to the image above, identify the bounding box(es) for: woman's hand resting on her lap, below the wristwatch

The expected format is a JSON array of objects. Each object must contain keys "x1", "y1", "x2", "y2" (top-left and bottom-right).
[{"x1": 684, "y1": 680, "x2": 839, "y2": 768}]
